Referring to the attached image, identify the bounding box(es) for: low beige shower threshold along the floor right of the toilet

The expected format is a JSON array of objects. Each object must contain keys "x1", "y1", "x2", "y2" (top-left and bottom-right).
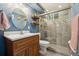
[{"x1": 48, "y1": 44, "x2": 70, "y2": 56}]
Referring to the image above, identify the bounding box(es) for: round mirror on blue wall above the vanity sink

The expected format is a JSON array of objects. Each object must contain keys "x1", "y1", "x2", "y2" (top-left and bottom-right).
[{"x1": 12, "y1": 8, "x2": 27, "y2": 30}]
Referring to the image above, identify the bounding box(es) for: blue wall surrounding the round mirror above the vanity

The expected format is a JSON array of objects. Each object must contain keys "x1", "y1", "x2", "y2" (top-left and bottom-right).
[{"x1": 0, "y1": 3, "x2": 38, "y2": 32}]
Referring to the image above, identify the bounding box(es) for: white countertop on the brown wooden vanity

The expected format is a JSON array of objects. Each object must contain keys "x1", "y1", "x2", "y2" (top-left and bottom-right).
[{"x1": 4, "y1": 32, "x2": 40, "y2": 41}]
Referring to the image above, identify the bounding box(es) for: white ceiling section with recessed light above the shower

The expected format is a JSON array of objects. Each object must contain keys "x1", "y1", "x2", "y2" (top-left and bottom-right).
[{"x1": 40, "y1": 3, "x2": 72, "y2": 11}]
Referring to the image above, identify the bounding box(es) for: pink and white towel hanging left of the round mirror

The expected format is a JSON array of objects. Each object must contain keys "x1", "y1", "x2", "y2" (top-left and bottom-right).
[{"x1": 0, "y1": 11, "x2": 10, "y2": 30}]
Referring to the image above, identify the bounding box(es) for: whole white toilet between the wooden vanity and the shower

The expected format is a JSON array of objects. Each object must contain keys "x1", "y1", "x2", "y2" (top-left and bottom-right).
[{"x1": 40, "y1": 40, "x2": 49, "y2": 55}]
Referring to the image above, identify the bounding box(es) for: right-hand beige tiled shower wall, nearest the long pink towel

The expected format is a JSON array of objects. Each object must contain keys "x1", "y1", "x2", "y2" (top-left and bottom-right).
[{"x1": 56, "y1": 10, "x2": 71, "y2": 46}]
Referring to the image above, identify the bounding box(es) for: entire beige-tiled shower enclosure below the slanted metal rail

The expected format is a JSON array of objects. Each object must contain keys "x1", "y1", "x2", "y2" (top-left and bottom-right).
[{"x1": 39, "y1": 8, "x2": 71, "y2": 55}]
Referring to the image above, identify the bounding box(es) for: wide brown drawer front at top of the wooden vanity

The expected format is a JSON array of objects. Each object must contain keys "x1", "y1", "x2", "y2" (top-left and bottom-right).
[{"x1": 13, "y1": 36, "x2": 39, "y2": 50}]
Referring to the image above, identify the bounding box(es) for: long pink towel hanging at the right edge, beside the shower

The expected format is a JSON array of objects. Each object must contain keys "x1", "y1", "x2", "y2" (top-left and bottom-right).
[{"x1": 68, "y1": 14, "x2": 79, "y2": 53}]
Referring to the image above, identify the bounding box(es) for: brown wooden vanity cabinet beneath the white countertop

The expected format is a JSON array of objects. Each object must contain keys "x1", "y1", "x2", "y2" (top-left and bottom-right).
[{"x1": 5, "y1": 35, "x2": 39, "y2": 56}]
